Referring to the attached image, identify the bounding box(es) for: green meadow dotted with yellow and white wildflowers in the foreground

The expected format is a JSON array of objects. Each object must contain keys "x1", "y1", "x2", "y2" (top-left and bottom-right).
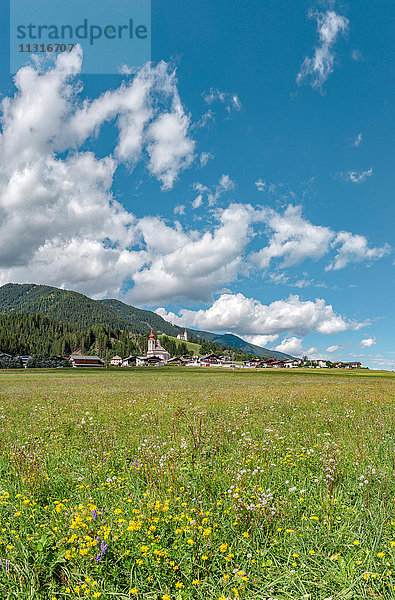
[{"x1": 0, "y1": 368, "x2": 395, "y2": 600}]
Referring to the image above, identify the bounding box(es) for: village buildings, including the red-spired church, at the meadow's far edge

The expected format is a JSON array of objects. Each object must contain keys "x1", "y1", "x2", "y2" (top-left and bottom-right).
[{"x1": 0, "y1": 329, "x2": 361, "y2": 369}]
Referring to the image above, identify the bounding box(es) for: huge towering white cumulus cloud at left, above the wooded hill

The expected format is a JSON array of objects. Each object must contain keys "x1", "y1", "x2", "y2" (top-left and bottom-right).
[{"x1": 0, "y1": 49, "x2": 194, "y2": 296}]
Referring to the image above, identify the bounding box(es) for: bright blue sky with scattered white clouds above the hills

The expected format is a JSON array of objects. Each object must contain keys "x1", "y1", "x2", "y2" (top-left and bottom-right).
[{"x1": 0, "y1": 0, "x2": 395, "y2": 368}]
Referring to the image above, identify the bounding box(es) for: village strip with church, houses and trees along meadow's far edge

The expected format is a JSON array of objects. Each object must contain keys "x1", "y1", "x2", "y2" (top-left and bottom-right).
[{"x1": 0, "y1": 329, "x2": 362, "y2": 369}]
